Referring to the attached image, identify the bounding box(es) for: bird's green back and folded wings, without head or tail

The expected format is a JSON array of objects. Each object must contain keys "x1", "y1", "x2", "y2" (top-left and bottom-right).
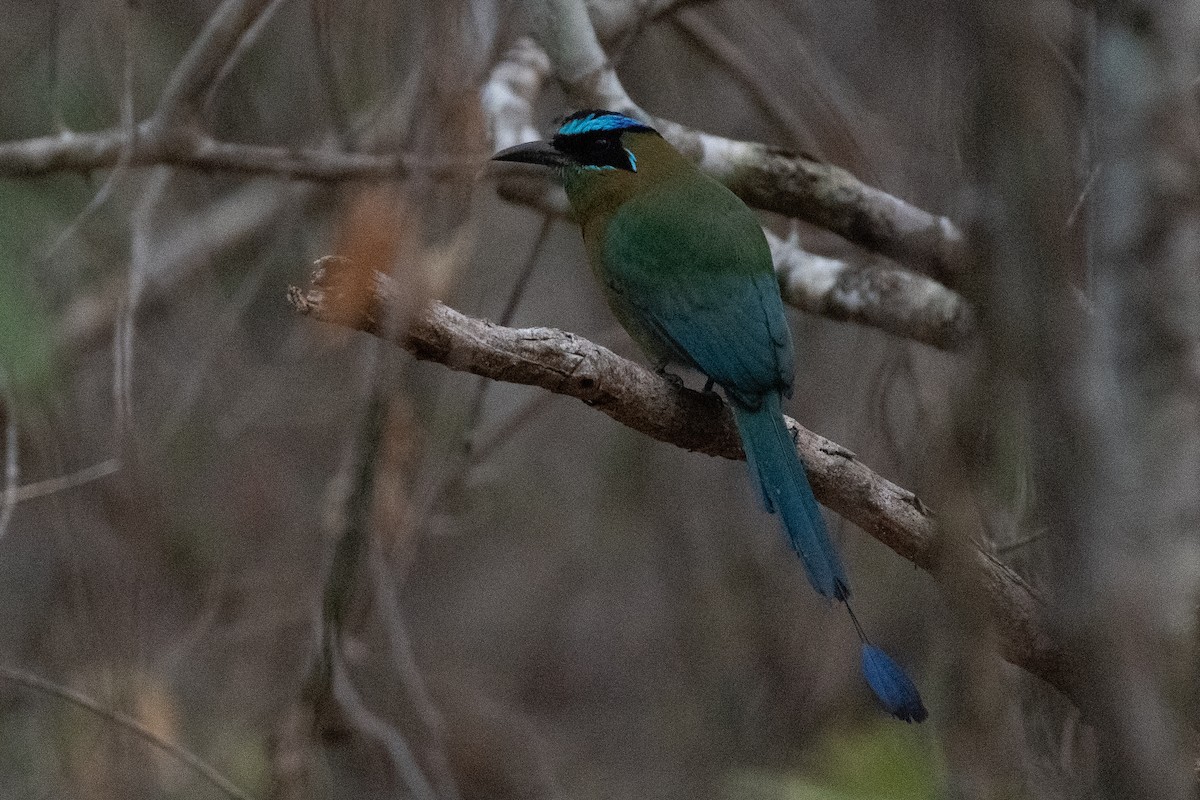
[{"x1": 583, "y1": 173, "x2": 792, "y2": 396}]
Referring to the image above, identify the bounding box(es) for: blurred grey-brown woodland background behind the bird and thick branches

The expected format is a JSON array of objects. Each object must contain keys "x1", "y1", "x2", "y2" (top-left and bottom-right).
[{"x1": 0, "y1": 0, "x2": 1200, "y2": 800}]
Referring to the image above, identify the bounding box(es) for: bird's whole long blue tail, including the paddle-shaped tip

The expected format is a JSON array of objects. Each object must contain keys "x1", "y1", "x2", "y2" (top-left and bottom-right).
[{"x1": 730, "y1": 392, "x2": 928, "y2": 722}]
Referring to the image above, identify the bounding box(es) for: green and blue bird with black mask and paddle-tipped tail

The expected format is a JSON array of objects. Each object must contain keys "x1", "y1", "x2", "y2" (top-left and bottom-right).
[{"x1": 492, "y1": 108, "x2": 928, "y2": 722}]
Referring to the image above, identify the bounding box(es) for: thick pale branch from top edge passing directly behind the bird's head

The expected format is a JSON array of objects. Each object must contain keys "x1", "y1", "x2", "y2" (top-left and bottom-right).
[{"x1": 526, "y1": 0, "x2": 965, "y2": 288}]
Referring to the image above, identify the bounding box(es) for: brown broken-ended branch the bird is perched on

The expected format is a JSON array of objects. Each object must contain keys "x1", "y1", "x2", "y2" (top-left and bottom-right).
[{"x1": 289, "y1": 258, "x2": 1076, "y2": 697}]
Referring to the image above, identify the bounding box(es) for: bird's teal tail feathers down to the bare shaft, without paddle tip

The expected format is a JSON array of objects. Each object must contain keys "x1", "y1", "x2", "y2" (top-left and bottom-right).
[{"x1": 731, "y1": 392, "x2": 850, "y2": 600}]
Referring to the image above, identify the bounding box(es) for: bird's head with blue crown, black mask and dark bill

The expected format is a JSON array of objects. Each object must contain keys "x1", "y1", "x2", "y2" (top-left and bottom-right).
[{"x1": 492, "y1": 108, "x2": 659, "y2": 179}]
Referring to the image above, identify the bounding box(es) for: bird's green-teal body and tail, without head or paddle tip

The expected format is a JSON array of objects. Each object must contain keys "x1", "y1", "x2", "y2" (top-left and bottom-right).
[{"x1": 578, "y1": 142, "x2": 846, "y2": 600}]
